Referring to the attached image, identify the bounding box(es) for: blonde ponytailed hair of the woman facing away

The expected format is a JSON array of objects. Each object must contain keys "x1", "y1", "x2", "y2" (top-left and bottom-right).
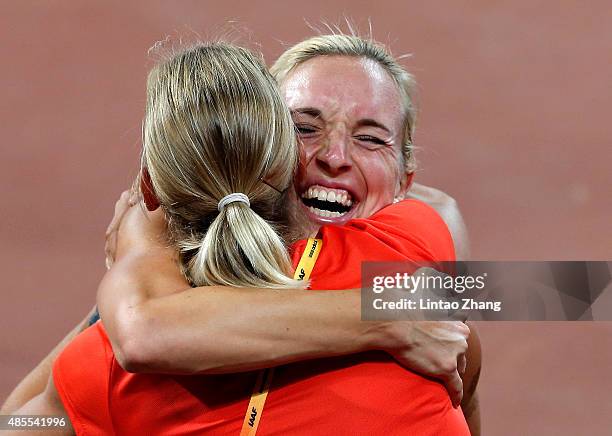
[{"x1": 141, "y1": 43, "x2": 299, "y2": 288}]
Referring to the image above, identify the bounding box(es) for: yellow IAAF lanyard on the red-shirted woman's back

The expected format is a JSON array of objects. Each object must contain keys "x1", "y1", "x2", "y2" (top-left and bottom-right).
[{"x1": 240, "y1": 238, "x2": 323, "y2": 436}]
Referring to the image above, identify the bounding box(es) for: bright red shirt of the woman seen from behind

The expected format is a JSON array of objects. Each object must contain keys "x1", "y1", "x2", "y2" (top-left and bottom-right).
[{"x1": 53, "y1": 200, "x2": 469, "y2": 436}]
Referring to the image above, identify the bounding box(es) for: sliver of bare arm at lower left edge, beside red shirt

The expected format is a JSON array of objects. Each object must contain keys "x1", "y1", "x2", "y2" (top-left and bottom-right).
[{"x1": 0, "y1": 308, "x2": 95, "y2": 414}]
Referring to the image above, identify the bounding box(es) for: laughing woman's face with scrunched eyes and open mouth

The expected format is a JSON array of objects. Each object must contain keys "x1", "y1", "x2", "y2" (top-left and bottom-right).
[{"x1": 281, "y1": 56, "x2": 409, "y2": 237}]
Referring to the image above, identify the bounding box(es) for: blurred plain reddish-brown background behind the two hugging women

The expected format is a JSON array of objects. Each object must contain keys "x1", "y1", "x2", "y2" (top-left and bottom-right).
[{"x1": 0, "y1": 0, "x2": 612, "y2": 435}]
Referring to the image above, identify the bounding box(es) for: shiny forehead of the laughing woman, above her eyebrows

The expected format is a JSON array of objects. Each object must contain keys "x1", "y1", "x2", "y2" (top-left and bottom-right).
[{"x1": 281, "y1": 56, "x2": 402, "y2": 124}]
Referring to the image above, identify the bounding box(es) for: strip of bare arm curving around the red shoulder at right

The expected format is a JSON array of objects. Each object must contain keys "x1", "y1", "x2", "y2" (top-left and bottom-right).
[{"x1": 407, "y1": 183, "x2": 470, "y2": 260}]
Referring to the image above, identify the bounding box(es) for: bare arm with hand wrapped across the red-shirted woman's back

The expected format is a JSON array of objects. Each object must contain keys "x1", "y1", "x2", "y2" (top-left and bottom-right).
[{"x1": 98, "y1": 199, "x2": 469, "y2": 404}]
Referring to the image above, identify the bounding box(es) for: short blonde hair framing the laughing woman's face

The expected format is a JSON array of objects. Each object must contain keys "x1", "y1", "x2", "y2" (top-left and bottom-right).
[{"x1": 270, "y1": 33, "x2": 416, "y2": 173}]
